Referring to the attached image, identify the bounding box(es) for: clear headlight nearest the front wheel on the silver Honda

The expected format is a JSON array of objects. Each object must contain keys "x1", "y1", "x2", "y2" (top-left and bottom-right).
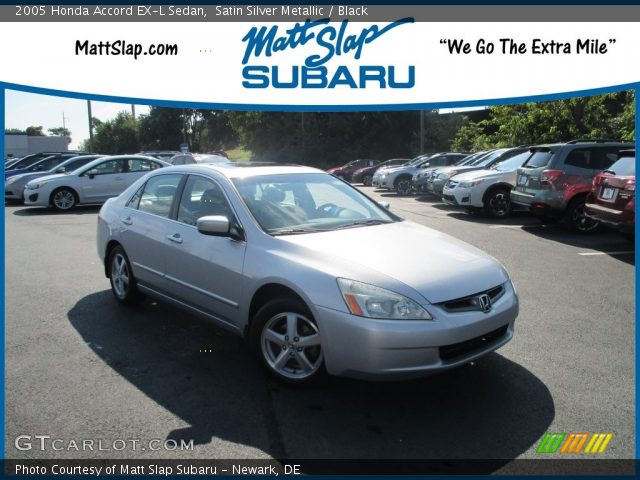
[{"x1": 338, "y1": 278, "x2": 433, "y2": 320}]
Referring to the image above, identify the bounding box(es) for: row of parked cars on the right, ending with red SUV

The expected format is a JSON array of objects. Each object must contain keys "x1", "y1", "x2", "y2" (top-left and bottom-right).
[{"x1": 356, "y1": 140, "x2": 635, "y2": 235}]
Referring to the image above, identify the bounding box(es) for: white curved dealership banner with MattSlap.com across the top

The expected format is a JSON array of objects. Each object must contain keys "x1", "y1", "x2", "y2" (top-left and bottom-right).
[{"x1": 0, "y1": 5, "x2": 640, "y2": 110}]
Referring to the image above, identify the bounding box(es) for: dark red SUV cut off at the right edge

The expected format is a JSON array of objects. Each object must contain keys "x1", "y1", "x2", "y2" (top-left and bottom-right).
[{"x1": 585, "y1": 150, "x2": 636, "y2": 237}]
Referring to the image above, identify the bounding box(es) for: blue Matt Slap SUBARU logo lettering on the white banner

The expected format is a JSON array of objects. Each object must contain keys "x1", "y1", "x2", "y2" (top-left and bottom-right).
[{"x1": 242, "y1": 18, "x2": 416, "y2": 88}]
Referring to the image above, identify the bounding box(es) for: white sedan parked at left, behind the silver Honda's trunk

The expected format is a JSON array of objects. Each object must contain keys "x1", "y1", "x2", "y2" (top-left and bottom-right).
[{"x1": 24, "y1": 155, "x2": 170, "y2": 210}]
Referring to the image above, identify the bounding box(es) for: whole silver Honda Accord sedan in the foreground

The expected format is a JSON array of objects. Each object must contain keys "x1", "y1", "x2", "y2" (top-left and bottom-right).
[{"x1": 97, "y1": 163, "x2": 518, "y2": 383}]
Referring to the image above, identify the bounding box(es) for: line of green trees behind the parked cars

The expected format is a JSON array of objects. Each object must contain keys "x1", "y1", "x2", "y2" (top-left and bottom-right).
[{"x1": 7, "y1": 90, "x2": 635, "y2": 167}]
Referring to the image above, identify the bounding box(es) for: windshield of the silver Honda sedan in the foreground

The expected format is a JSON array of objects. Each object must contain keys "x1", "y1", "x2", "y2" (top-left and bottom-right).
[{"x1": 233, "y1": 173, "x2": 398, "y2": 235}]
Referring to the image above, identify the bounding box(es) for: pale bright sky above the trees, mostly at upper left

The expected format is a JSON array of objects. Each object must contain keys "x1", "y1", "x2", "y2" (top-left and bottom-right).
[{"x1": 4, "y1": 90, "x2": 484, "y2": 150}]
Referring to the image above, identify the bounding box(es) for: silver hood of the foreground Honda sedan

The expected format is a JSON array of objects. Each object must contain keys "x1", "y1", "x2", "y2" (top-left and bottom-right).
[{"x1": 275, "y1": 221, "x2": 509, "y2": 303}]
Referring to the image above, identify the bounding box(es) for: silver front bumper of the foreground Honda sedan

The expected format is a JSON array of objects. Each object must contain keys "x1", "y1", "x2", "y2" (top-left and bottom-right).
[{"x1": 315, "y1": 282, "x2": 518, "y2": 380}]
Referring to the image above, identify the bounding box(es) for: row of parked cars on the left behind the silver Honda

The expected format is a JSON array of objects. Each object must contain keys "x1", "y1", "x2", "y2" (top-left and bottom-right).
[{"x1": 4, "y1": 152, "x2": 235, "y2": 210}]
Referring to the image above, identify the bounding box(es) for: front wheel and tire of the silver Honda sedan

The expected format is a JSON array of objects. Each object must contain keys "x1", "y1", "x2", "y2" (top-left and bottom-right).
[{"x1": 251, "y1": 298, "x2": 325, "y2": 385}]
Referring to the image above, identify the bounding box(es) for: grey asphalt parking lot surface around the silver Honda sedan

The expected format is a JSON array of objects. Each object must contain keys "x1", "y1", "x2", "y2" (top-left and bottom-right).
[{"x1": 5, "y1": 187, "x2": 635, "y2": 465}]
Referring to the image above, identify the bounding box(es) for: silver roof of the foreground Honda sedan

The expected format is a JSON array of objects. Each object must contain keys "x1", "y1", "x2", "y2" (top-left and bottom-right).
[{"x1": 162, "y1": 162, "x2": 322, "y2": 179}]
